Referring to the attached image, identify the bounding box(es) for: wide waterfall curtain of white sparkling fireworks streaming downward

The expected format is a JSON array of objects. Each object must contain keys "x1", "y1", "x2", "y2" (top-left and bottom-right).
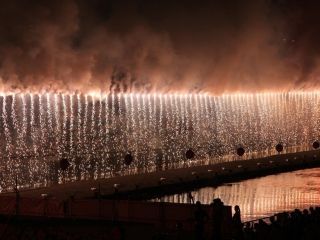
[{"x1": 0, "y1": 92, "x2": 320, "y2": 190}]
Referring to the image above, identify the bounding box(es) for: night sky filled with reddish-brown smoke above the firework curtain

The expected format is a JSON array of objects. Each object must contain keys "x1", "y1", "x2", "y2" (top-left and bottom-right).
[{"x1": 0, "y1": 0, "x2": 320, "y2": 93}]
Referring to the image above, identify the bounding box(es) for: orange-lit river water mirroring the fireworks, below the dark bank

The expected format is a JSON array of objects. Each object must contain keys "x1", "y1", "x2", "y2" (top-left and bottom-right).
[{"x1": 152, "y1": 168, "x2": 320, "y2": 221}]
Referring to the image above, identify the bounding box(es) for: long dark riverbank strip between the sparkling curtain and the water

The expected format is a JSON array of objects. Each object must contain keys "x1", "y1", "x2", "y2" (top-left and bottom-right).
[{"x1": 0, "y1": 150, "x2": 320, "y2": 199}]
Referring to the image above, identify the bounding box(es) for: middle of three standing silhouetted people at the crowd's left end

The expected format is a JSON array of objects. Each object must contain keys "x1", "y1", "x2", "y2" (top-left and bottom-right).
[{"x1": 211, "y1": 198, "x2": 224, "y2": 240}]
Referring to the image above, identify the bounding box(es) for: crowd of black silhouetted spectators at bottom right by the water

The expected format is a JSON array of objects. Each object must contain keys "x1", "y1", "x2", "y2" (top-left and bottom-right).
[{"x1": 194, "y1": 199, "x2": 320, "y2": 240}]
